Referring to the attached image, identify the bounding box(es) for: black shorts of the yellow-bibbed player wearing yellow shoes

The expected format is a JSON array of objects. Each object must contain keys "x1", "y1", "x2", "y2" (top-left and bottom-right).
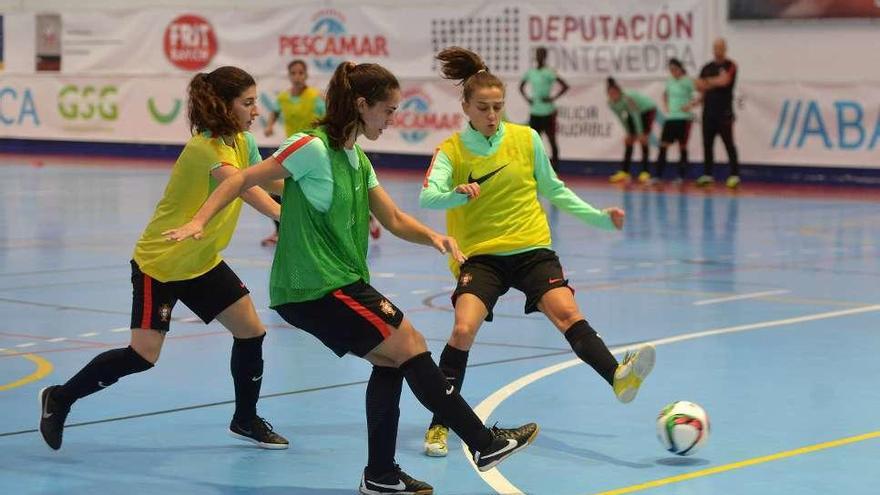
[{"x1": 452, "y1": 249, "x2": 574, "y2": 321}]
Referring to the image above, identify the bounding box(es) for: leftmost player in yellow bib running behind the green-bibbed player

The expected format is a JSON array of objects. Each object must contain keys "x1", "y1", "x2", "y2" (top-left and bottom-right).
[{"x1": 40, "y1": 67, "x2": 288, "y2": 450}]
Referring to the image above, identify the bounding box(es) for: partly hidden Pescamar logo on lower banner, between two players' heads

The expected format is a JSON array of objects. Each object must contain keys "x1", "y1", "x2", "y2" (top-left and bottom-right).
[{"x1": 394, "y1": 88, "x2": 464, "y2": 143}]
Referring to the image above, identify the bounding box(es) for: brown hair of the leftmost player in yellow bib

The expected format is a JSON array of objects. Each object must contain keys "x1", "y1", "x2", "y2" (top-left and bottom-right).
[{"x1": 187, "y1": 66, "x2": 257, "y2": 136}]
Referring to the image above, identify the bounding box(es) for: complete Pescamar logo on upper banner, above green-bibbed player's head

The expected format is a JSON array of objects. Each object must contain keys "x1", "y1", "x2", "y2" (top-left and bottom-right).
[{"x1": 278, "y1": 9, "x2": 388, "y2": 72}]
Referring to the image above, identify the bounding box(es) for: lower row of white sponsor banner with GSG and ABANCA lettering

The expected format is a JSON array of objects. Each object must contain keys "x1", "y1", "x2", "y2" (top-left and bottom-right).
[{"x1": 0, "y1": 75, "x2": 880, "y2": 168}]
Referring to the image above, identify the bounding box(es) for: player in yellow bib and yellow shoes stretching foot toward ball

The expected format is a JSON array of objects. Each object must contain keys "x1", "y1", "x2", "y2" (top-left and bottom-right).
[{"x1": 419, "y1": 47, "x2": 654, "y2": 457}]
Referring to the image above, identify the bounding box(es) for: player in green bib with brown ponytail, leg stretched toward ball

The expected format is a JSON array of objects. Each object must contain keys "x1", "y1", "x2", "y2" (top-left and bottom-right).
[{"x1": 167, "y1": 62, "x2": 538, "y2": 495}]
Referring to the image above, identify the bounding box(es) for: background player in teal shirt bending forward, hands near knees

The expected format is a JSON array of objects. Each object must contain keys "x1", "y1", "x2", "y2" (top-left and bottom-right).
[{"x1": 607, "y1": 77, "x2": 657, "y2": 184}]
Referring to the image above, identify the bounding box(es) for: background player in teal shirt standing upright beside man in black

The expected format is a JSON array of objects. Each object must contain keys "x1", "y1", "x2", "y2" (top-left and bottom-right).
[{"x1": 657, "y1": 58, "x2": 694, "y2": 181}]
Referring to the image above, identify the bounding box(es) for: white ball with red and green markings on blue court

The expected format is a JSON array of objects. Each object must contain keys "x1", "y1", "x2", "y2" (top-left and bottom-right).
[{"x1": 657, "y1": 400, "x2": 709, "y2": 455}]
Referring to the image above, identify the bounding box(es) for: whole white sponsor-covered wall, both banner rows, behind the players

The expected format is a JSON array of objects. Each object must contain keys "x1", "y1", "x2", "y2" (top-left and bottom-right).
[{"x1": 0, "y1": 0, "x2": 880, "y2": 168}]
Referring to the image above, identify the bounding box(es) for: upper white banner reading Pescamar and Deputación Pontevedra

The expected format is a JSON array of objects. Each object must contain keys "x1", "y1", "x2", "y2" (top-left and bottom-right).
[{"x1": 0, "y1": 0, "x2": 708, "y2": 78}]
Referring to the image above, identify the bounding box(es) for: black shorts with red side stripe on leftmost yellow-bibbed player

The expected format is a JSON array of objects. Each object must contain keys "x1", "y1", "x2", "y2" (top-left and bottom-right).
[{"x1": 131, "y1": 260, "x2": 250, "y2": 332}]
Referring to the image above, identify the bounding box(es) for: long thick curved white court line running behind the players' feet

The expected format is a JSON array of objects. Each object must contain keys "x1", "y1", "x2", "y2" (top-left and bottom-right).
[{"x1": 461, "y1": 304, "x2": 880, "y2": 495}]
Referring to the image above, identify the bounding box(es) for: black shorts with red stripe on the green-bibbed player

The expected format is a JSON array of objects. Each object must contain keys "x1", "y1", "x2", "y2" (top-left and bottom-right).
[{"x1": 273, "y1": 280, "x2": 403, "y2": 357}]
